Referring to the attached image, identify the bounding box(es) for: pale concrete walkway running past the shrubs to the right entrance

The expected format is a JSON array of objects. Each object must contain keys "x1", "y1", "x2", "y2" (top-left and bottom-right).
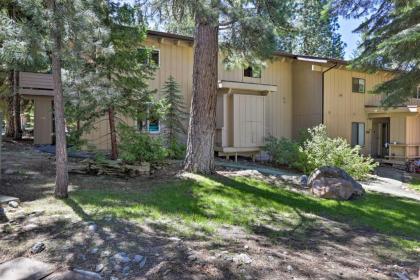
[{"x1": 216, "y1": 160, "x2": 420, "y2": 201}]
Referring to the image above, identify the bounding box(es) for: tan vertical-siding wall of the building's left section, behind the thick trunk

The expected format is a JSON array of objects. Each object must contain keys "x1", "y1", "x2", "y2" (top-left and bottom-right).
[{"x1": 84, "y1": 37, "x2": 292, "y2": 150}]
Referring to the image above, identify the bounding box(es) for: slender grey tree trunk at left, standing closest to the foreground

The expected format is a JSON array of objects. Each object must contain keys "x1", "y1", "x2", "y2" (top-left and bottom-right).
[{"x1": 49, "y1": 0, "x2": 69, "y2": 198}]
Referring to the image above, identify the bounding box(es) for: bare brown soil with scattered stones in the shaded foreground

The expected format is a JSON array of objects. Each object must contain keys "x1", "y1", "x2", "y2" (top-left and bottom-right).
[{"x1": 0, "y1": 143, "x2": 420, "y2": 279}]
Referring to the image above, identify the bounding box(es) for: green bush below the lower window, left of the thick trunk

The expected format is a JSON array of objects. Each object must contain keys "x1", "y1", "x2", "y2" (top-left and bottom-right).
[{"x1": 118, "y1": 124, "x2": 168, "y2": 164}]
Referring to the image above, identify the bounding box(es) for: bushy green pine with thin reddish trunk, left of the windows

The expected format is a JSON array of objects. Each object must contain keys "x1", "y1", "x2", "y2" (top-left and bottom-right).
[{"x1": 66, "y1": 1, "x2": 156, "y2": 159}]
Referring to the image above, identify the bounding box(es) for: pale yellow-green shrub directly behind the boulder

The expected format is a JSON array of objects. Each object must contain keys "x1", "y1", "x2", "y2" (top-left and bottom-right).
[{"x1": 299, "y1": 125, "x2": 377, "y2": 179}]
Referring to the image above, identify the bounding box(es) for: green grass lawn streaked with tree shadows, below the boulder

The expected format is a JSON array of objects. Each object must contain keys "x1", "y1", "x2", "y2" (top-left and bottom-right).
[{"x1": 67, "y1": 175, "x2": 420, "y2": 248}]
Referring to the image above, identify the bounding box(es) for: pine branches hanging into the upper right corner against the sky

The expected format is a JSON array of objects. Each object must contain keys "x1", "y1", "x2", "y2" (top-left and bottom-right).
[{"x1": 331, "y1": 0, "x2": 420, "y2": 106}]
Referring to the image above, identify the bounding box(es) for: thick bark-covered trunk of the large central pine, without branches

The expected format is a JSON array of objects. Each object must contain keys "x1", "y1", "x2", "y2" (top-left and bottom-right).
[{"x1": 184, "y1": 16, "x2": 218, "y2": 174}]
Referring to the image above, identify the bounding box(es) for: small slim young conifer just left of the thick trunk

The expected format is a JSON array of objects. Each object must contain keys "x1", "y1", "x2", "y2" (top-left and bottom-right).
[{"x1": 163, "y1": 75, "x2": 188, "y2": 157}]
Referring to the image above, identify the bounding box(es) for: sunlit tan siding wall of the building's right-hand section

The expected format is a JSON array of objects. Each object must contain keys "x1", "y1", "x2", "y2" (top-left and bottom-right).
[{"x1": 324, "y1": 69, "x2": 390, "y2": 154}]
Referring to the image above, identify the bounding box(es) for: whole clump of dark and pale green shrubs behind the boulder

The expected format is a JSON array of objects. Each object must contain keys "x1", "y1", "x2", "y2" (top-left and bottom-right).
[{"x1": 264, "y1": 125, "x2": 377, "y2": 180}]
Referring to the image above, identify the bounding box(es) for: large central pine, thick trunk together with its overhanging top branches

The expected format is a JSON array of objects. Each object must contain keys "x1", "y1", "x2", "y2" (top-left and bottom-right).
[{"x1": 146, "y1": 0, "x2": 291, "y2": 174}]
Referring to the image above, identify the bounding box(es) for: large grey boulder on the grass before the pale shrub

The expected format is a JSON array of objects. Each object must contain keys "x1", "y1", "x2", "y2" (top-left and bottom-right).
[{"x1": 308, "y1": 166, "x2": 365, "y2": 200}]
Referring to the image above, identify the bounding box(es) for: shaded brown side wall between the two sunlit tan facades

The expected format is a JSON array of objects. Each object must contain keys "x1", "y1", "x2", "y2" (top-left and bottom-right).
[{"x1": 292, "y1": 61, "x2": 322, "y2": 138}]
